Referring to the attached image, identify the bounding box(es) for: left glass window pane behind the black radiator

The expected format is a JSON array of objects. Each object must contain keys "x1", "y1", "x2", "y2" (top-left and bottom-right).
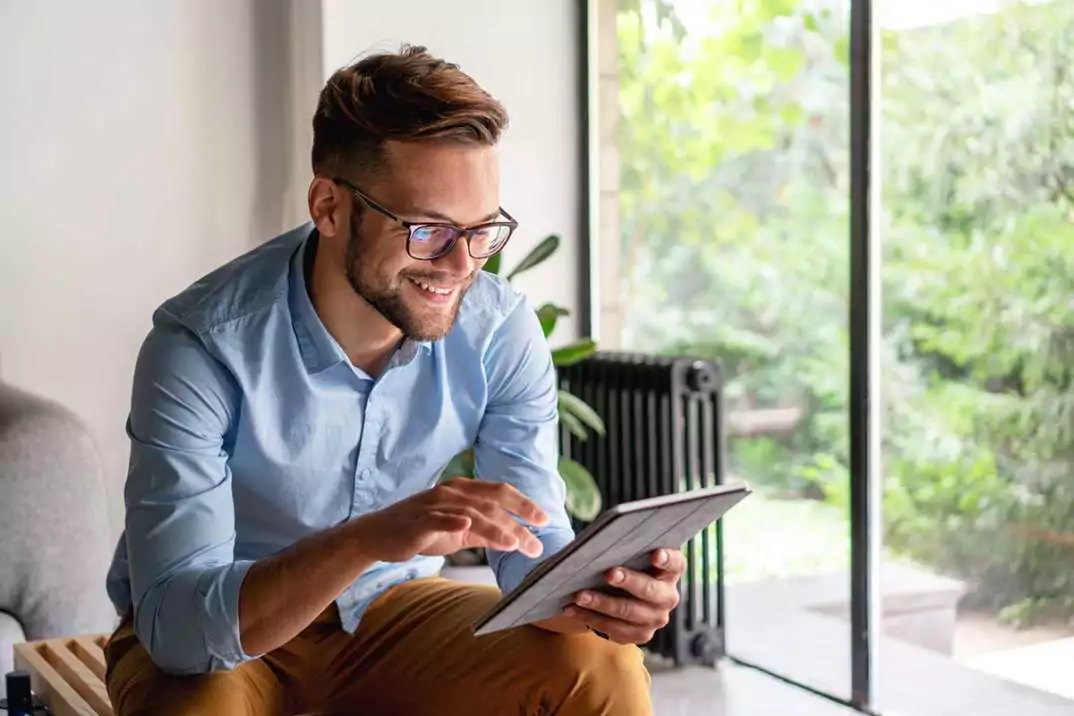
[{"x1": 600, "y1": 0, "x2": 851, "y2": 698}]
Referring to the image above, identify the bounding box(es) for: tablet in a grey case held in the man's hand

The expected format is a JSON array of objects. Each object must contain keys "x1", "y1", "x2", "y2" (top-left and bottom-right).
[{"x1": 474, "y1": 483, "x2": 751, "y2": 637}]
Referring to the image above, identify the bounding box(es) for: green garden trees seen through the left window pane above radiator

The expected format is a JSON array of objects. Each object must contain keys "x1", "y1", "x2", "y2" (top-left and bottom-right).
[{"x1": 619, "y1": 1, "x2": 848, "y2": 493}]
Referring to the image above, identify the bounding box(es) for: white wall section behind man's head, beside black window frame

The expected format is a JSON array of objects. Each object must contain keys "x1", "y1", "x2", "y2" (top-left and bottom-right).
[{"x1": 322, "y1": 0, "x2": 585, "y2": 345}]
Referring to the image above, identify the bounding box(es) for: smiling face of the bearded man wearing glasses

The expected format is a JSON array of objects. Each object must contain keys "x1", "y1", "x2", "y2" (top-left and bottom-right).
[{"x1": 346, "y1": 143, "x2": 499, "y2": 340}]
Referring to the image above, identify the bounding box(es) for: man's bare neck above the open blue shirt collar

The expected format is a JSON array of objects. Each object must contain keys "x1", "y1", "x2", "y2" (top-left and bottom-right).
[{"x1": 307, "y1": 238, "x2": 403, "y2": 378}]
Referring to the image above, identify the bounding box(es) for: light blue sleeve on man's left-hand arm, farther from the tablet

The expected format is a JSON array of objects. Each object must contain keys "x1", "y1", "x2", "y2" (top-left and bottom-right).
[{"x1": 125, "y1": 317, "x2": 253, "y2": 674}]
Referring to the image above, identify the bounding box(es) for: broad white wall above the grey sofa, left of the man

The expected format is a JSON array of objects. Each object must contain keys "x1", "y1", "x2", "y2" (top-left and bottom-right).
[{"x1": 0, "y1": 0, "x2": 319, "y2": 528}]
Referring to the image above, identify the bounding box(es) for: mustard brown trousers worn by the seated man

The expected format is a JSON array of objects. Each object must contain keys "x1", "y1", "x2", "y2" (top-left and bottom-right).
[{"x1": 105, "y1": 578, "x2": 652, "y2": 716}]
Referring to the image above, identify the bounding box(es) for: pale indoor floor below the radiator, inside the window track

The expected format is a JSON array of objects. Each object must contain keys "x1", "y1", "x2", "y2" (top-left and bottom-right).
[{"x1": 652, "y1": 662, "x2": 857, "y2": 716}]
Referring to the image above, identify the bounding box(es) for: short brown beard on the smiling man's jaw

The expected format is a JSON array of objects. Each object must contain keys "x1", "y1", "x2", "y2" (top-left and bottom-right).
[{"x1": 345, "y1": 213, "x2": 474, "y2": 341}]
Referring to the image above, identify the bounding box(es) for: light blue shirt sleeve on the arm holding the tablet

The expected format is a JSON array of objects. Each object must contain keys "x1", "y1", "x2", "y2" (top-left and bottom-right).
[{"x1": 474, "y1": 301, "x2": 575, "y2": 594}]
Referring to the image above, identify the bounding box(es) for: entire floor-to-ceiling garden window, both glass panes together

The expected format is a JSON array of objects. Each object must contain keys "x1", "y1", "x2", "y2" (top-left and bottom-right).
[{"x1": 594, "y1": 0, "x2": 1074, "y2": 714}]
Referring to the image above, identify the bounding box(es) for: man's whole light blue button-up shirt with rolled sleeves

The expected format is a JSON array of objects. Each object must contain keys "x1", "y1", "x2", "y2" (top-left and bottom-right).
[{"x1": 107, "y1": 224, "x2": 574, "y2": 673}]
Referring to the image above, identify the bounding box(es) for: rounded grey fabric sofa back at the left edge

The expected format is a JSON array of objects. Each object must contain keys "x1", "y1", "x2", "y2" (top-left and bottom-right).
[{"x1": 0, "y1": 383, "x2": 115, "y2": 682}]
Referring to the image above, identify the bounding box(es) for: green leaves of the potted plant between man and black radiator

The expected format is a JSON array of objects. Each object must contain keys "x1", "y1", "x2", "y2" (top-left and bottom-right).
[{"x1": 442, "y1": 234, "x2": 605, "y2": 521}]
